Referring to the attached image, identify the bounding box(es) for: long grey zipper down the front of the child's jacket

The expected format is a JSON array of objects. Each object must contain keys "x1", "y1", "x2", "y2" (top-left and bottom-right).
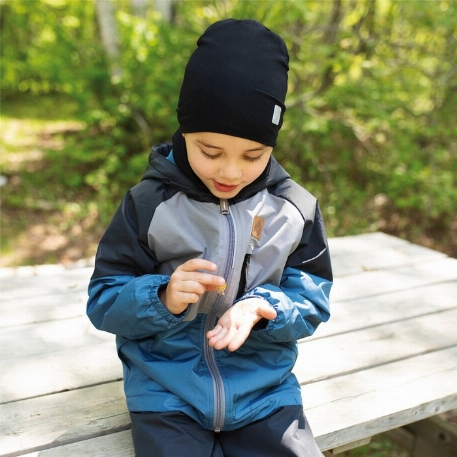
[{"x1": 204, "y1": 199, "x2": 235, "y2": 432}]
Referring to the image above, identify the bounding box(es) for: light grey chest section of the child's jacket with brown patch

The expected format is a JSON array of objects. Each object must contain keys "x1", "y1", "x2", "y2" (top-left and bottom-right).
[{"x1": 148, "y1": 190, "x2": 304, "y2": 318}]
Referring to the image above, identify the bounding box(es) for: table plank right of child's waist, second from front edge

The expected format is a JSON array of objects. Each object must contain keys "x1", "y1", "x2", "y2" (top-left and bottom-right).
[{"x1": 294, "y1": 309, "x2": 457, "y2": 384}]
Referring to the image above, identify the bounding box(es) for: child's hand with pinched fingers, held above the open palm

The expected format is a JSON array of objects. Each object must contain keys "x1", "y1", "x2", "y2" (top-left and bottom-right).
[{"x1": 159, "y1": 259, "x2": 225, "y2": 314}]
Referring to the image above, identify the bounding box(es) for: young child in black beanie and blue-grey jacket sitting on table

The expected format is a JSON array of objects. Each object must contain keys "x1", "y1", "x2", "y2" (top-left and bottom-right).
[{"x1": 87, "y1": 19, "x2": 332, "y2": 457}]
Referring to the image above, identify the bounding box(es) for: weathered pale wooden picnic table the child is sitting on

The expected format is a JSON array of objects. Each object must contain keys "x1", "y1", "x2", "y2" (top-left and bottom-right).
[{"x1": 0, "y1": 233, "x2": 457, "y2": 457}]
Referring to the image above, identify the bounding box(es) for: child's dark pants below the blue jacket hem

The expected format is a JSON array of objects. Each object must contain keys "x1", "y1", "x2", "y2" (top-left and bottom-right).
[{"x1": 130, "y1": 406, "x2": 322, "y2": 457}]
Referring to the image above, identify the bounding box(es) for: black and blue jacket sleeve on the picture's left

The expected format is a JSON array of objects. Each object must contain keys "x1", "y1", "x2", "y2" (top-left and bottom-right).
[{"x1": 87, "y1": 182, "x2": 185, "y2": 339}]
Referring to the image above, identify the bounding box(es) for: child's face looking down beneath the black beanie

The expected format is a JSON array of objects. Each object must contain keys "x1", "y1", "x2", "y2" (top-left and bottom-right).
[{"x1": 183, "y1": 132, "x2": 273, "y2": 199}]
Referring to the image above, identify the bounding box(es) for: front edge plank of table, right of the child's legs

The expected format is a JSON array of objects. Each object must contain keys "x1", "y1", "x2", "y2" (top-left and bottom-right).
[{"x1": 302, "y1": 347, "x2": 457, "y2": 449}]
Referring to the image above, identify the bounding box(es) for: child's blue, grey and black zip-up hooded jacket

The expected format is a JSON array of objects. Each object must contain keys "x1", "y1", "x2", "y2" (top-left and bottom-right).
[{"x1": 87, "y1": 144, "x2": 332, "y2": 430}]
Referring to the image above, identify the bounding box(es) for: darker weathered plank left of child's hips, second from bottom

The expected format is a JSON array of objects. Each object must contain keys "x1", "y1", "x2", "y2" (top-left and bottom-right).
[{"x1": 0, "y1": 381, "x2": 124, "y2": 455}]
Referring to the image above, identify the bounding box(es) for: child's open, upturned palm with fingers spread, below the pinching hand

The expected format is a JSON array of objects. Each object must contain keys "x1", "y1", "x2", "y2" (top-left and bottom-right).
[{"x1": 206, "y1": 298, "x2": 276, "y2": 351}]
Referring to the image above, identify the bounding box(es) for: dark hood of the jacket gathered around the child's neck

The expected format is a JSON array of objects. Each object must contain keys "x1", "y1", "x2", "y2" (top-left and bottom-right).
[{"x1": 142, "y1": 139, "x2": 290, "y2": 203}]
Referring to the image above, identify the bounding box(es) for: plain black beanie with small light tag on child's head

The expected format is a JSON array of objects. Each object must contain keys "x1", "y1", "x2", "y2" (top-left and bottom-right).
[{"x1": 177, "y1": 19, "x2": 289, "y2": 146}]
